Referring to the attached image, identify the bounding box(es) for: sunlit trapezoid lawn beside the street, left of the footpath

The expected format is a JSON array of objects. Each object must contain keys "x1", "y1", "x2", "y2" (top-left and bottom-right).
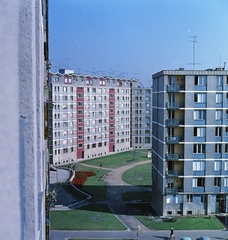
[{"x1": 50, "y1": 204, "x2": 126, "y2": 230}]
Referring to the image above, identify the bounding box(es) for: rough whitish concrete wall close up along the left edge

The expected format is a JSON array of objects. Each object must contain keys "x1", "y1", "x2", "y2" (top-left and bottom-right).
[{"x1": 0, "y1": 0, "x2": 45, "y2": 240}]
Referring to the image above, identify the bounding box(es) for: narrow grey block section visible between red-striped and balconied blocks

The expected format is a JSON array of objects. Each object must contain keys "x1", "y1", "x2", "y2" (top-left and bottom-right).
[{"x1": 131, "y1": 87, "x2": 152, "y2": 149}]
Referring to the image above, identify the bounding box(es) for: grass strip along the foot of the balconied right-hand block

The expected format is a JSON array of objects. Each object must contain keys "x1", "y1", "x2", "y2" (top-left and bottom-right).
[{"x1": 136, "y1": 216, "x2": 223, "y2": 230}]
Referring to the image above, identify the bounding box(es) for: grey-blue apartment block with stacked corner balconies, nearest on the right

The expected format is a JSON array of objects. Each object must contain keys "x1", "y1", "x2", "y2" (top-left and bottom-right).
[{"x1": 152, "y1": 68, "x2": 228, "y2": 216}]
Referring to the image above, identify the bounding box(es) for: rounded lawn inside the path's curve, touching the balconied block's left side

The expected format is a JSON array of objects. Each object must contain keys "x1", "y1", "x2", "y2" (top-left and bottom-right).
[{"x1": 122, "y1": 163, "x2": 152, "y2": 188}]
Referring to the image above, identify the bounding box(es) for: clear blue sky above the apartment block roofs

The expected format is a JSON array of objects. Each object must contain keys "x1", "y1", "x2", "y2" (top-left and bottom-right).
[{"x1": 49, "y1": 0, "x2": 228, "y2": 86}]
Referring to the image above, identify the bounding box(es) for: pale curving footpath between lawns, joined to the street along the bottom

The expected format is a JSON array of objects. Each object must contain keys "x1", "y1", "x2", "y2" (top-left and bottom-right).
[{"x1": 51, "y1": 160, "x2": 228, "y2": 240}]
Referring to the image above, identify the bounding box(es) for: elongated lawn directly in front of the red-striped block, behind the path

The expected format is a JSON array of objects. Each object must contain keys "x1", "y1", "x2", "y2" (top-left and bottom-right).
[{"x1": 80, "y1": 150, "x2": 150, "y2": 168}]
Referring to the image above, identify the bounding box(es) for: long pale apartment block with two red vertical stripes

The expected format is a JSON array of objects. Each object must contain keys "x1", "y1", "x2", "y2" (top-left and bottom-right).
[{"x1": 49, "y1": 70, "x2": 141, "y2": 166}]
